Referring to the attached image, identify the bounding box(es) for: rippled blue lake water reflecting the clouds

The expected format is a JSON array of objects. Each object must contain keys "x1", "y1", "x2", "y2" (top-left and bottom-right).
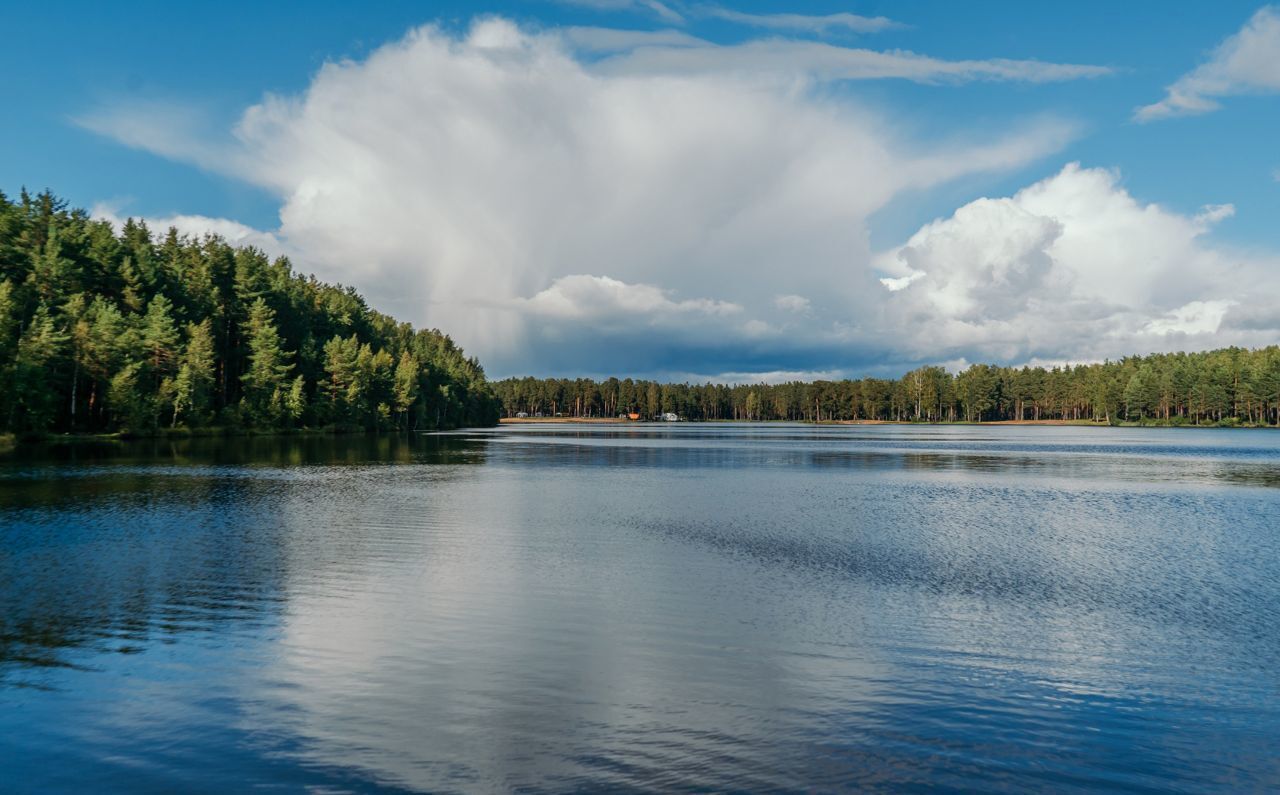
[{"x1": 0, "y1": 425, "x2": 1280, "y2": 792}]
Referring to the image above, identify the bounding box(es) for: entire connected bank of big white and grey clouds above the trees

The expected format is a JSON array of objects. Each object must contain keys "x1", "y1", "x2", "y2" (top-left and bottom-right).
[{"x1": 83, "y1": 18, "x2": 1270, "y2": 376}]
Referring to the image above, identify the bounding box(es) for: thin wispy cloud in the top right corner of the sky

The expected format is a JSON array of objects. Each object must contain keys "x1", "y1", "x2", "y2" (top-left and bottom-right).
[{"x1": 1134, "y1": 6, "x2": 1280, "y2": 122}]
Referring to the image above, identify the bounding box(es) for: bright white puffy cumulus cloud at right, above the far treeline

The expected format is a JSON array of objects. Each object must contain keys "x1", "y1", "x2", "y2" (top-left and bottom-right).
[{"x1": 877, "y1": 164, "x2": 1280, "y2": 361}]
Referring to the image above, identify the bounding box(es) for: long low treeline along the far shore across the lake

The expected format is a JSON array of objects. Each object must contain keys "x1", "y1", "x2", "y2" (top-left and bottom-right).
[{"x1": 494, "y1": 346, "x2": 1280, "y2": 425}]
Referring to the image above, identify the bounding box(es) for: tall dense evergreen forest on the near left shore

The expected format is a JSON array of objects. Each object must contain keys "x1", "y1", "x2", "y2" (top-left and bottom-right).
[{"x1": 0, "y1": 191, "x2": 499, "y2": 434}]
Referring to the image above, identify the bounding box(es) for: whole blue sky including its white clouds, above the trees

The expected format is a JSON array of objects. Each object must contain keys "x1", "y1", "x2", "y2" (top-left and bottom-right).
[{"x1": 0, "y1": 0, "x2": 1280, "y2": 381}]
